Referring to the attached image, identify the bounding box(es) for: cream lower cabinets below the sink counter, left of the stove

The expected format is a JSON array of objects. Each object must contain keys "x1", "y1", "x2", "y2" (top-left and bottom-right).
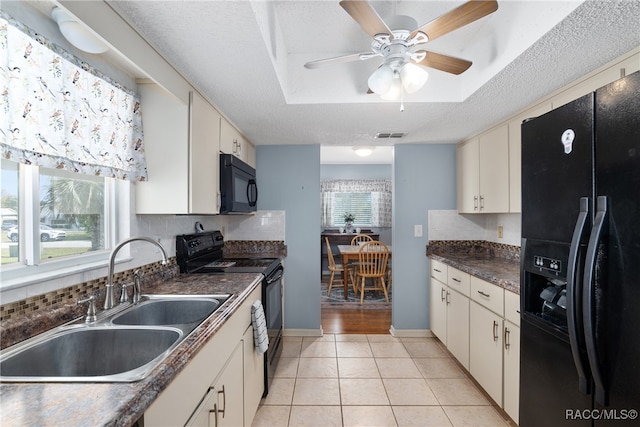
[{"x1": 144, "y1": 286, "x2": 264, "y2": 427}]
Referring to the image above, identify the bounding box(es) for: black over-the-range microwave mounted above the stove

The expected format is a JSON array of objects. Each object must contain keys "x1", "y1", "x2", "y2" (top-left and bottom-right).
[{"x1": 220, "y1": 153, "x2": 258, "y2": 214}]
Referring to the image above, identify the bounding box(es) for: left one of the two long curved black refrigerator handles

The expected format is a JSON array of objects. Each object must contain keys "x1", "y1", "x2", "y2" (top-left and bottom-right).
[{"x1": 567, "y1": 197, "x2": 591, "y2": 394}]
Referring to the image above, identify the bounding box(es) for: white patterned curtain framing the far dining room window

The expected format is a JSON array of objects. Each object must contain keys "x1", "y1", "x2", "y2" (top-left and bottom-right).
[{"x1": 320, "y1": 179, "x2": 392, "y2": 227}]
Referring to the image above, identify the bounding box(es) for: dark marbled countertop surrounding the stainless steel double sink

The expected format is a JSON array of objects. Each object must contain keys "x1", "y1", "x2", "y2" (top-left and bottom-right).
[{"x1": 0, "y1": 273, "x2": 262, "y2": 427}]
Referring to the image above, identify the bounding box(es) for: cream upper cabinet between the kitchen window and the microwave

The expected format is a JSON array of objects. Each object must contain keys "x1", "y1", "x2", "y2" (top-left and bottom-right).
[{"x1": 136, "y1": 83, "x2": 220, "y2": 214}]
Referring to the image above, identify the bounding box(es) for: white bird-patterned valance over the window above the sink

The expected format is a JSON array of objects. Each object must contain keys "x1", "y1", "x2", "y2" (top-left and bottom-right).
[{"x1": 0, "y1": 11, "x2": 147, "y2": 181}]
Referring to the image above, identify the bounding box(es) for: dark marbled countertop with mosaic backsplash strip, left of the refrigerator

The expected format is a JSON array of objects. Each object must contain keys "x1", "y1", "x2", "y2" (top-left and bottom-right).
[{"x1": 427, "y1": 241, "x2": 520, "y2": 294}]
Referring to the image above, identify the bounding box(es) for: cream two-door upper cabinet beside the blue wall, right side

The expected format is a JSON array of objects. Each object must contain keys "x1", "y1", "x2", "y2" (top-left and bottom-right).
[{"x1": 457, "y1": 125, "x2": 509, "y2": 213}]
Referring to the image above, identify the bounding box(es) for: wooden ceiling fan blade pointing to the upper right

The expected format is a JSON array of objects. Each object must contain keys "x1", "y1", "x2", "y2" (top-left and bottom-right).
[{"x1": 410, "y1": 0, "x2": 498, "y2": 40}]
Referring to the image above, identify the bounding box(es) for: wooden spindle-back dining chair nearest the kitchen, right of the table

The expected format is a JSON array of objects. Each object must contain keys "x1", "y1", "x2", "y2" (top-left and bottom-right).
[{"x1": 356, "y1": 240, "x2": 389, "y2": 304}]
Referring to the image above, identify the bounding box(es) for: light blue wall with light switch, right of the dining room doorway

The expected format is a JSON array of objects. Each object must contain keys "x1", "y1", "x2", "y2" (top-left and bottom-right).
[{"x1": 392, "y1": 144, "x2": 456, "y2": 330}]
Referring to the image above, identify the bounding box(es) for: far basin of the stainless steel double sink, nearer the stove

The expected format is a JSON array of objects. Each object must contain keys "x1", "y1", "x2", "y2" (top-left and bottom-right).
[{"x1": 111, "y1": 295, "x2": 229, "y2": 328}]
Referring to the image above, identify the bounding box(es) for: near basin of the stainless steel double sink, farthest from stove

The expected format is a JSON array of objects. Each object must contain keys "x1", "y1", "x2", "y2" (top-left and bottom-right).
[{"x1": 0, "y1": 325, "x2": 184, "y2": 382}]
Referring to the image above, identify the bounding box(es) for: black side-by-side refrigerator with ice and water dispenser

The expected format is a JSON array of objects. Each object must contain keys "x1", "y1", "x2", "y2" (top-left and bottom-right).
[{"x1": 520, "y1": 72, "x2": 640, "y2": 427}]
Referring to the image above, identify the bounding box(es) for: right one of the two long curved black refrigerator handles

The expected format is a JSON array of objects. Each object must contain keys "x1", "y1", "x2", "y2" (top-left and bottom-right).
[{"x1": 582, "y1": 196, "x2": 609, "y2": 406}]
